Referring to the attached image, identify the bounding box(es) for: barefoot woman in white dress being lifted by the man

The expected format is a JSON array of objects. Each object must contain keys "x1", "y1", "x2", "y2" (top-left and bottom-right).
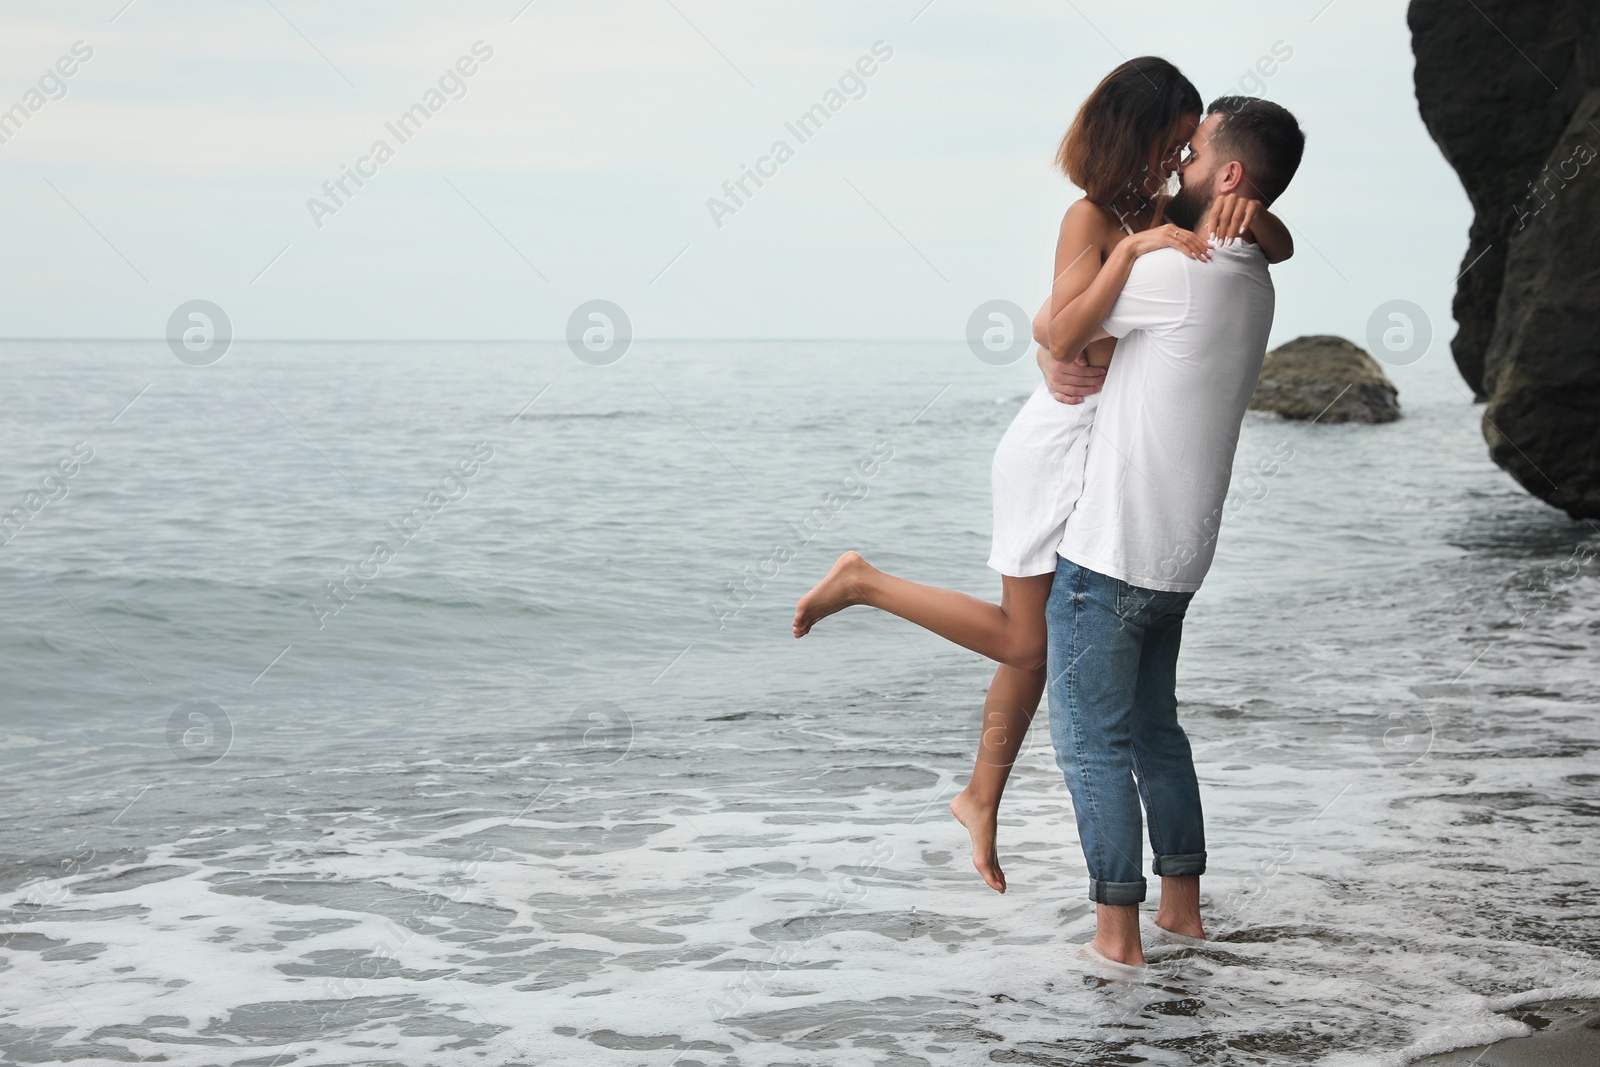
[{"x1": 794, "y1": 56, "x2": 1293, "y2": 893}]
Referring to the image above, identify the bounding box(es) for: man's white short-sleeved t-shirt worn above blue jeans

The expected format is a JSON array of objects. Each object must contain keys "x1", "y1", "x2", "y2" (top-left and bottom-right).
[{"x1": 1058, "y1": 242, "x2": 1274, "y2": 592}]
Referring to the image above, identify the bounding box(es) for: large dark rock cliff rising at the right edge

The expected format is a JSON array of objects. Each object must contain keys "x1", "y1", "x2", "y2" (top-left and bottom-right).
[{"x1": 1408, "y1": 0, "x2": 1600, "y2": 518}]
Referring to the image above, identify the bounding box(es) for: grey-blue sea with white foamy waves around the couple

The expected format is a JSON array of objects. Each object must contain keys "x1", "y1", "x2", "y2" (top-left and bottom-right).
[{"x1": 0, "y1": 339, "x2": 1600, "y2": 1067}]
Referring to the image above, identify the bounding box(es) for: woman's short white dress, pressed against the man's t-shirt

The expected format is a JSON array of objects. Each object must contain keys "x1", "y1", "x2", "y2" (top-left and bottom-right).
[{"x1": 989, "y1": 382, "x2": 1099, "y2": 577}]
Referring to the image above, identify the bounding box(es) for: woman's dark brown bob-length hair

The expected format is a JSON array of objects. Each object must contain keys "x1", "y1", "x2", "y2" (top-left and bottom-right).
[{"x1": 1056, "y1": 56, "x2": 1202, "y2": 206}]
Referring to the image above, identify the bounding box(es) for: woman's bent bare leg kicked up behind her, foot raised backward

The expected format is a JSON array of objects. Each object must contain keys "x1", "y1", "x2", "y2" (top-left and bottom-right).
[{"x1": 794, "y1": 552, "x2": 1054, "y2": 670}]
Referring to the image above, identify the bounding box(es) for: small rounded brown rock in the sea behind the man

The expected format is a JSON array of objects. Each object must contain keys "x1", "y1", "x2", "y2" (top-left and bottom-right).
[{"x1": 1250, "y1": 336, "x2": 1400, "y2": 422}]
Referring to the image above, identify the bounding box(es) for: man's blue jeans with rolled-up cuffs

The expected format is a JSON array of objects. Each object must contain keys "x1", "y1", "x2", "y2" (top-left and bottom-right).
[{"x1": 1045, "y1": 558, "x2": 1205, "y2": 904}]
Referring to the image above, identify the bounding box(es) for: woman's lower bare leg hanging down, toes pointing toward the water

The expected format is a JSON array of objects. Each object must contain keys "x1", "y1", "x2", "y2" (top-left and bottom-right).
[{"x1": 950, "y1": 664, "x2": 1045, "y2": 893}]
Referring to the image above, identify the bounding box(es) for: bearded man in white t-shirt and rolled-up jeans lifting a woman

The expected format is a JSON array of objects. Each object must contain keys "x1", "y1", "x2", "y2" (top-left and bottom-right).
[{"x1": 1042, "y1": 96, "x2": 1306, "y2": 966}]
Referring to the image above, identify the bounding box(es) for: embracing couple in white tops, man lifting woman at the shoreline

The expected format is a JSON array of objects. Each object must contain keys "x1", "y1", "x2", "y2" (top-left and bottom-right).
[{"x1": 794, "y1": 56, "x2": 1306, "y2": 968}]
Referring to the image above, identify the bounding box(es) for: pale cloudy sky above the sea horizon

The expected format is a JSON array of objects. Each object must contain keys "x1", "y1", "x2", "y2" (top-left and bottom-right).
[{"x1": 0, "y1": 0, "x2": 1472, "y2": 346}]
